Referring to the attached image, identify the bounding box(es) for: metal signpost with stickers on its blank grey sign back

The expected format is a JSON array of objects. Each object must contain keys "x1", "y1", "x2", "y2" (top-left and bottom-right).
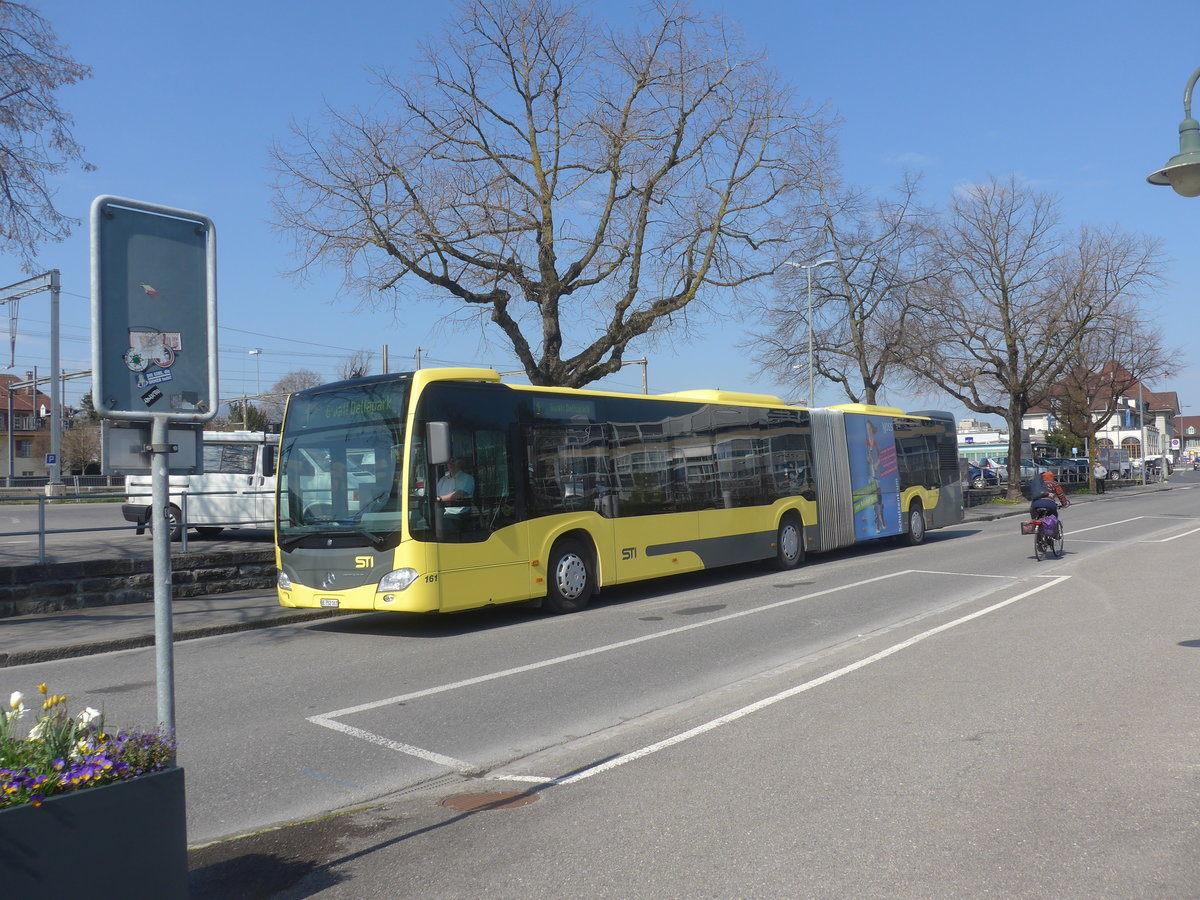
[{"x1": 91, "y1": 196, "x2": 220, "y2": 732}]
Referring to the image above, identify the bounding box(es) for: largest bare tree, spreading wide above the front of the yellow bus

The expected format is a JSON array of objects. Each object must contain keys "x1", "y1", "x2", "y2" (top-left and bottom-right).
[{"x1": 272, "y1": 0, "x2": 829, "y2": 386}]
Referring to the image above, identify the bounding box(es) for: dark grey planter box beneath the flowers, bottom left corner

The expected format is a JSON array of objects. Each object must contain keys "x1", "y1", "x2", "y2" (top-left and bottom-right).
[{"x1": 0, "y1": 767, "x2": 187, "y2": 900}]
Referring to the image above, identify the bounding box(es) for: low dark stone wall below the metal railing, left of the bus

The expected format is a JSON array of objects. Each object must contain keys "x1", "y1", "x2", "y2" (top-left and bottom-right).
[{"x1": 0, "y1": 548, "x2": 275, "y2": 618}]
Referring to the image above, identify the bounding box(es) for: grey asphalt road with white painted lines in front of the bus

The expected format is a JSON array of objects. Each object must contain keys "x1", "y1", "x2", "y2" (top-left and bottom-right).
[{"x1": 6, "y1": 479, "x2": 1200, "y2": 899}]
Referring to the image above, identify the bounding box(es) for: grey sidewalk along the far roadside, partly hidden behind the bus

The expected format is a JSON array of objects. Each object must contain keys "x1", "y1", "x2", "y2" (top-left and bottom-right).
[{"x1": 0, "y1": 481, "x2": 1171, "y2": 668}]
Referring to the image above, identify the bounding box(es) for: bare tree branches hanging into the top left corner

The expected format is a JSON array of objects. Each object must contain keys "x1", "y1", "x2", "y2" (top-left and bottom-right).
[{"x1": 0, "y1": 2, "x2": 94, "y2": 271}]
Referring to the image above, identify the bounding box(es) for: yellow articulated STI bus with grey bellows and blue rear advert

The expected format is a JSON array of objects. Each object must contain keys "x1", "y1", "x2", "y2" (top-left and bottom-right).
[{"x1": 276, "y1": 368, "x2": 962, "y2": 612}]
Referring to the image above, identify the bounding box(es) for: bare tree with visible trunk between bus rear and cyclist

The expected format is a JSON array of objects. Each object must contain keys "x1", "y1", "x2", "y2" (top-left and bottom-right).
[{"x1": 905, "y1": 178, "x2": 1162, "y2": 499}]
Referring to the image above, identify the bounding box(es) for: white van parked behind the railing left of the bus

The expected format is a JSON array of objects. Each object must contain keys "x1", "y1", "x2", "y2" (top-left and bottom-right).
[{"x1": 121, "y1": 431, "x2": 280, "y2": 540}]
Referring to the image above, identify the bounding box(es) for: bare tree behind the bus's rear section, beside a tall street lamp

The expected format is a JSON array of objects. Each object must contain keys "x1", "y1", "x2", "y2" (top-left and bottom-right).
[{"x1": 748, "y1": 173, "x2": 937, "y2": 404}]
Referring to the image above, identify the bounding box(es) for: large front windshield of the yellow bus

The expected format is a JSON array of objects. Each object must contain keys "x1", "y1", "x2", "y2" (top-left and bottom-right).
[{"x1": 276, "y1": 378, "x2": 408, "y2": 548}]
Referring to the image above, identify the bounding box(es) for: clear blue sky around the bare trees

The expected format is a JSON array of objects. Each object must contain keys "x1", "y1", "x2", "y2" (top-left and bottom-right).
[{"x1": 16, "y1": 0, "x2": 1200, "y2": 427}]
